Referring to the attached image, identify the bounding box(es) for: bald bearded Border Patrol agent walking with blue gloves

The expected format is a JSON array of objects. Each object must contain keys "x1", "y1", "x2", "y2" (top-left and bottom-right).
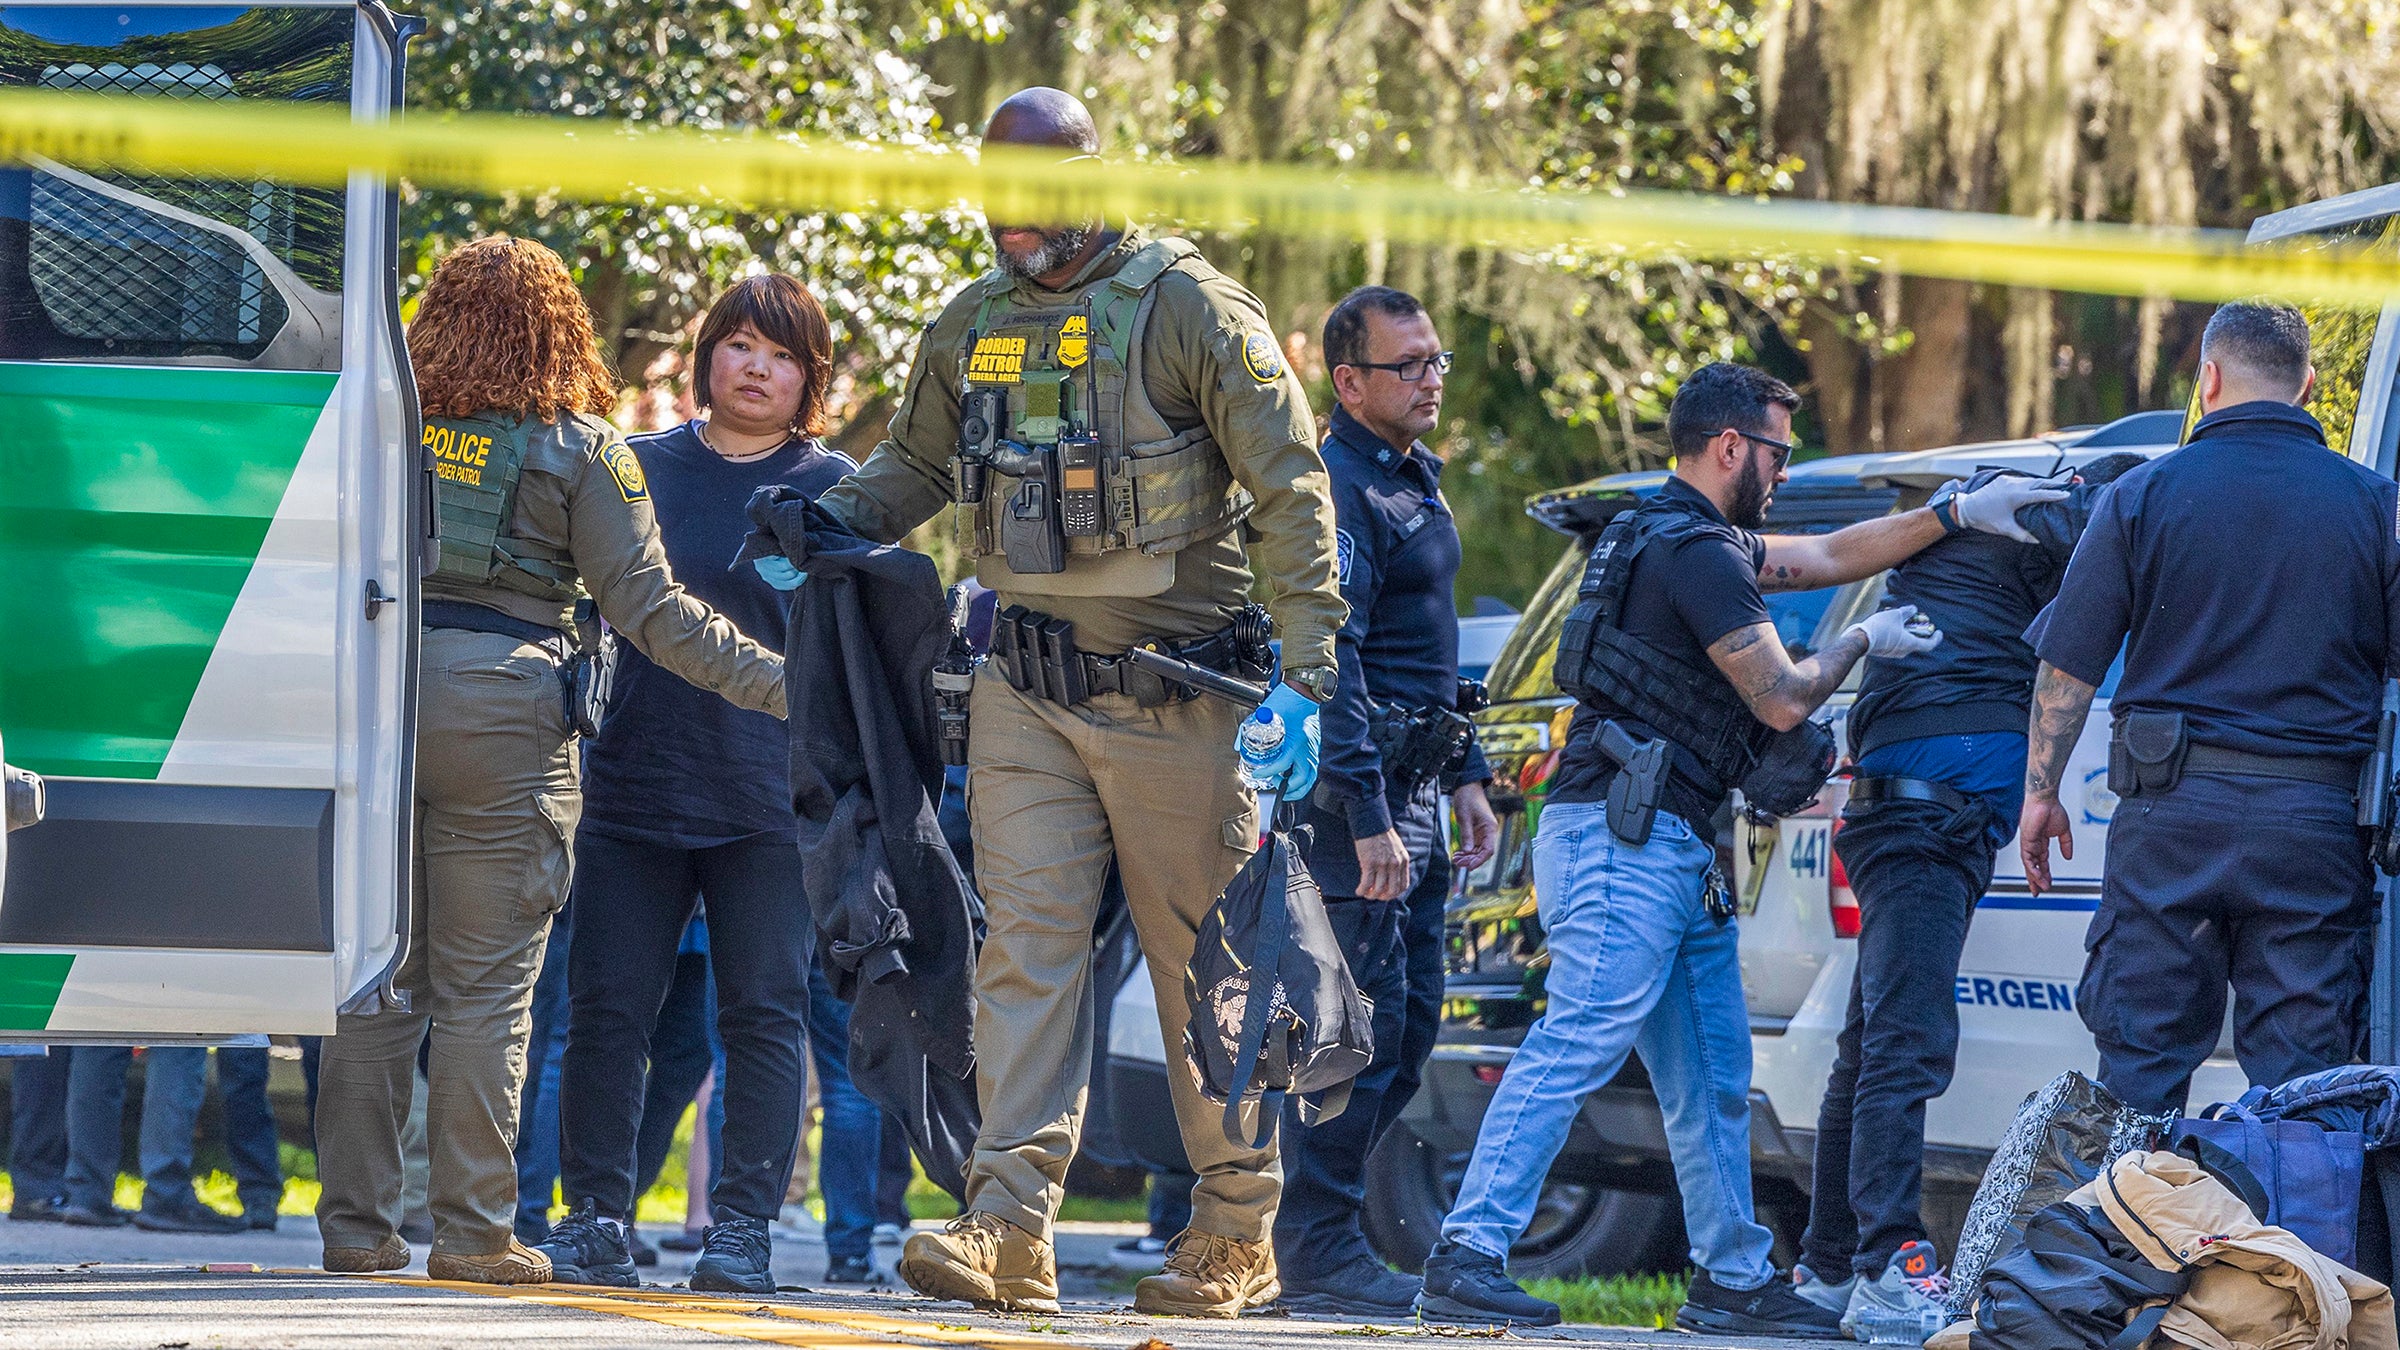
[{"x1": 821, "y1": 89, "x2": 1344, "y2": 1316}]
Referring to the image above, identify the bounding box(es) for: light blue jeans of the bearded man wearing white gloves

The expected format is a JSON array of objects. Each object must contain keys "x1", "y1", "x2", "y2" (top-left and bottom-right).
[{"x1": 1442, "y1": 802, "x2": 1776, "y2": 1290}]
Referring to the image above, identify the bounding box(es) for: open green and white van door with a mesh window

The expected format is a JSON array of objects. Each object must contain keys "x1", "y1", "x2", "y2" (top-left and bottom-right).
[{"x1": 0, "y1": 2, "x2": 430, "y2": 1028}]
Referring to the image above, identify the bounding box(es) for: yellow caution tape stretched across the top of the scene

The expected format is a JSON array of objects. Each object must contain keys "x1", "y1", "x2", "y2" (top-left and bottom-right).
[{"x1": 0, "y1": 89, "x2": 2400, "y2": 305}]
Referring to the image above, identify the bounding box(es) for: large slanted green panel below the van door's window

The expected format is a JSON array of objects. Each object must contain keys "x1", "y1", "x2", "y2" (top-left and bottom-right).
[{"x1": 0, "y1": 363, "x2": 336, "y2": 778}]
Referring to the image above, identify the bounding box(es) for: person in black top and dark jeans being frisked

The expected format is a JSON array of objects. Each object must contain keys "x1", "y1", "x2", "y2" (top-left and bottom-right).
[{"x1": 1793, "y1": 454, "x2": 2143, "y2": 1343}]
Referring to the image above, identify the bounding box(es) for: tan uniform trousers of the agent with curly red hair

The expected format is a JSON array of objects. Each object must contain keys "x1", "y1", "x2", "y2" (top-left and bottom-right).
[{"x1": 317, "y1": 629, "x2": 583, "y2": 1254}]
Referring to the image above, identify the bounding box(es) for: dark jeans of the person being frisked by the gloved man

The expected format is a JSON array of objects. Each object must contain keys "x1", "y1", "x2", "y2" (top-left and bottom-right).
[{"x1": 1800, "y1": 800, "x2": 1992, "y2": 1280}]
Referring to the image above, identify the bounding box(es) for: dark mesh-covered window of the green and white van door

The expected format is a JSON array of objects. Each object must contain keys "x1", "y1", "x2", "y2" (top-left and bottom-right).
[{"x1": 0, "y1": 5, "x2": 355, "y2": 370}]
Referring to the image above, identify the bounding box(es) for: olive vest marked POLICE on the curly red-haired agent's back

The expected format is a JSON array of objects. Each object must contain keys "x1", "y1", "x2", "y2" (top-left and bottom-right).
[{"x1": 425, "y1": 418, "x2": 578, "y2": 605}]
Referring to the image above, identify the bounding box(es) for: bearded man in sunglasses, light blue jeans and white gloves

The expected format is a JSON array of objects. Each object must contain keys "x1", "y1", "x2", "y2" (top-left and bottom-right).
[{"x1": 1418, "y1": 363, "x2": 2064, "y2": 1340}]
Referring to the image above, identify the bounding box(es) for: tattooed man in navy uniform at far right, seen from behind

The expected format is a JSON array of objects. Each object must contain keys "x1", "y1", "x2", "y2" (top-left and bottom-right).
[{"x1": 2018, "y1": 305, "x2": 2400, "y2": 1112}]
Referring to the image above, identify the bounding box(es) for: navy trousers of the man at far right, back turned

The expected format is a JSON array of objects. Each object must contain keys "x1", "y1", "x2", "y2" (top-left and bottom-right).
[{"x1": 2076, "y1": 773, "x2": 2376, "y2": 1112}]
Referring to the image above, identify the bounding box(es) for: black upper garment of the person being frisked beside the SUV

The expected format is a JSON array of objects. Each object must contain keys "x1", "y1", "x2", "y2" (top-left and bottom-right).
[{"x1": 1850, "y1": 468, "x2": 2110, "y2": 757}]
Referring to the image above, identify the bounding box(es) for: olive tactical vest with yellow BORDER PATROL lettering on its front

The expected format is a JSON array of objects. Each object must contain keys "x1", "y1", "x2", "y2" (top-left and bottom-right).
[{"x1": 960, "y1": 238, "x2": 1250, "y2": 596}]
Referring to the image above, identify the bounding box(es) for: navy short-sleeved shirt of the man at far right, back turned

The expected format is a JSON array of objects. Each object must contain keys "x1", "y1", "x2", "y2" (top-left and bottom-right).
[{"x1": 2026, "y1": 404, "x2": 2400, "y2": 757}]
